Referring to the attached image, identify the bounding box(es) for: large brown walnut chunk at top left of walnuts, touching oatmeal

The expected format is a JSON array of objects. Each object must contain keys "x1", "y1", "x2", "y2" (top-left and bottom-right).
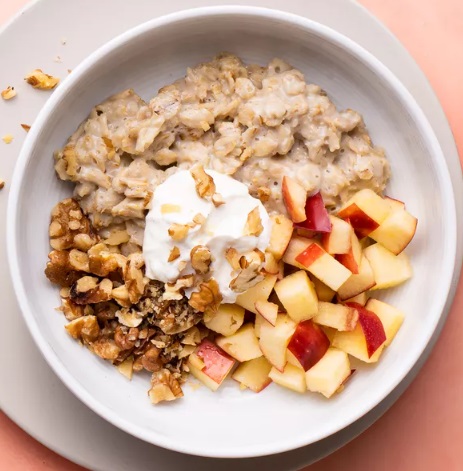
[{"x1": 49, "y1": 198, "x2": 98, "y2": 251}]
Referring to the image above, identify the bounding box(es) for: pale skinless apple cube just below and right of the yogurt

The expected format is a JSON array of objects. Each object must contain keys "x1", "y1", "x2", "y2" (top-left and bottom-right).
[{"x1": 276, "y1": 270, "x2": 318, "y2": 322}]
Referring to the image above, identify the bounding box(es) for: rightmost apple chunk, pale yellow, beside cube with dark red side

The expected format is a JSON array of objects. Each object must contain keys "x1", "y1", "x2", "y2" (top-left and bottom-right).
[{"x1": 370, "y1": 209, "x2": 418, "y2": 255}]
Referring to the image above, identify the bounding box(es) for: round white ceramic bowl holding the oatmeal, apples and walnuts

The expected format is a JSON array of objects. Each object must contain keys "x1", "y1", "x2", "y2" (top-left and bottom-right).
[{"x1": 7, "y1": 6, "x2": 456, "y2": 457}]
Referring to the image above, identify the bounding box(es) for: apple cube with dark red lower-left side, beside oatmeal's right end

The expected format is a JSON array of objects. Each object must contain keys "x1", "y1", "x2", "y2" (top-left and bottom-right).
[{"x1": 338, "y1": 189, "x2": 391, "y2": 238}]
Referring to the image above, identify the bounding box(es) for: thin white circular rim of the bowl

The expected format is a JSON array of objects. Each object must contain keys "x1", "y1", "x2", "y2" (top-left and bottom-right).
[{"x1": 7, "y1": 5, "x2": 457, "y2": 458}]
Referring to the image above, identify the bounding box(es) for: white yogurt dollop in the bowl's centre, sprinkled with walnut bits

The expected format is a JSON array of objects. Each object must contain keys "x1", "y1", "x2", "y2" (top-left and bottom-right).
[{"x1": 143, "y1": 170, "x2": 270, "y2": 303}]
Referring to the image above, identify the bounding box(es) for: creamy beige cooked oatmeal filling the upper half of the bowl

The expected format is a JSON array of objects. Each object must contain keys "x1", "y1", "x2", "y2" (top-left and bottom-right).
[{"x1": 55, "y1": 54, "x2": 390, "y2": 250}]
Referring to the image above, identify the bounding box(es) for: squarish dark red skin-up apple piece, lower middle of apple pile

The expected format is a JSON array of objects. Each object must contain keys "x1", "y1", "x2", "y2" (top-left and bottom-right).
[{"x1": 288, "y1": 320, "x2": 330, "y2": 371}]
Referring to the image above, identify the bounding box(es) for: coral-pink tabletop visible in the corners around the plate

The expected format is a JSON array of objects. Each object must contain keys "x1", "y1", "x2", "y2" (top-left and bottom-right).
[{"x1": 0, "y1": 0, "x2": 463, "y2": 471}]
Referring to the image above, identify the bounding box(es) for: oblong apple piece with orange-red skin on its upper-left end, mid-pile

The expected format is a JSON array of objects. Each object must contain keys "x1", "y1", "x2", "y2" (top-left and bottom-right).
[{"x1": 296, "y1": 244, "x2": 352, "y2": 291}]
